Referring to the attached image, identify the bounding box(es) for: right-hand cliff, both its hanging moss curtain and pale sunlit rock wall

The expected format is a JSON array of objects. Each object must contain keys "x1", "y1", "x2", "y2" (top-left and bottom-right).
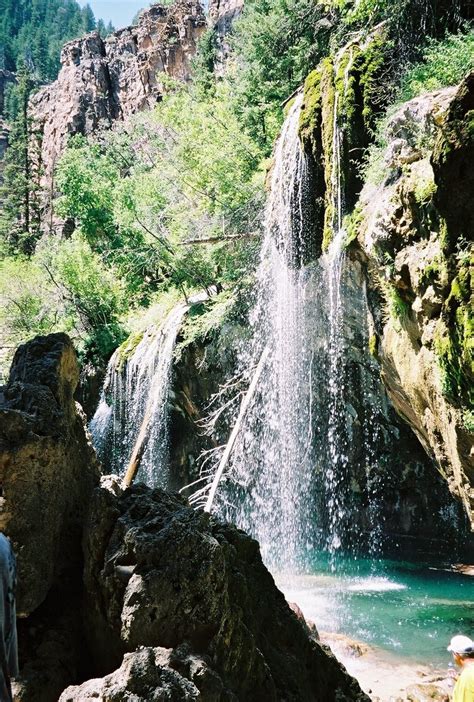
[{"x1": 300, "y1": 49, "x2": 474, "y2": 544}]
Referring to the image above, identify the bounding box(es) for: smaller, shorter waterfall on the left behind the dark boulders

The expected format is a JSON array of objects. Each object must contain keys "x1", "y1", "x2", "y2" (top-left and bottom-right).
[{"x1": 90, "y1": 304, "x2": 189, "y2": 487}]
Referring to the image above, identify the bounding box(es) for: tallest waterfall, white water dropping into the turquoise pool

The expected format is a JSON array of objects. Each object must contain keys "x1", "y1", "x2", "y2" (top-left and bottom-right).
[{"x1": 208, "y1": 75, "x2": 386, "y2": 573}]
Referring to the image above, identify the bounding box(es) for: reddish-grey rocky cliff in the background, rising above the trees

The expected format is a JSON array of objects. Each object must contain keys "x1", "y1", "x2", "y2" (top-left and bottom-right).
[{"x1": 31, "y1": 0, "x2": 206, "y2": 194}]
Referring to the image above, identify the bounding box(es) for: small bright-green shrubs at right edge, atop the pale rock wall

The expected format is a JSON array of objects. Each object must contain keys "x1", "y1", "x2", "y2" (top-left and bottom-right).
[{"x1": 397, "y1": 31, "x2": 474, "y2": 102}]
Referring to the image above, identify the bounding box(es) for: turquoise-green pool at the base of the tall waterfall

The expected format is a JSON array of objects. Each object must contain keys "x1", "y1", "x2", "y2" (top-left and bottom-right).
[{"x1": 276, "y1": 560, "x2": 474, "y2": 668}]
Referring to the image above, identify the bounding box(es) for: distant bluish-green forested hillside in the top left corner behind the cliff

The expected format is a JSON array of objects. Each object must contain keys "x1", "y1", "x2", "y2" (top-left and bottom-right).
[{"x1": 0, "y1": 0, "x2": 112, "y2": 88}]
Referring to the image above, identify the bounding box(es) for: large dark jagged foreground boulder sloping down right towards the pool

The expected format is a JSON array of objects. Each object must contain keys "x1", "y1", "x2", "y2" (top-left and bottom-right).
[{"x1": 83, "y1": 485, "x2": 367, "y2": 702}]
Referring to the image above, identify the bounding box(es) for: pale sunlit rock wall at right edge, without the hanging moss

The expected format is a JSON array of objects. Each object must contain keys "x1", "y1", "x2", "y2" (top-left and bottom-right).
[{"x1": 357, "y1": 75, "x2": 474, "y2": 532}]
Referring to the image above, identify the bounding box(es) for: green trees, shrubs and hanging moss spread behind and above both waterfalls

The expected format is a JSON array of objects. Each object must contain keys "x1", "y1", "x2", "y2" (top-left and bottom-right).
[{"x1": 0, "y1": 0, "x2": 473, "y2": 374}]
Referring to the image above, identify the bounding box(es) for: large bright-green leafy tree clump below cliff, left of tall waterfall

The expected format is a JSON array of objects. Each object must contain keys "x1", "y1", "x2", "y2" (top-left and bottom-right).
[{"x1": 57, "y1": 79, "x2": 263, "y2": 304}]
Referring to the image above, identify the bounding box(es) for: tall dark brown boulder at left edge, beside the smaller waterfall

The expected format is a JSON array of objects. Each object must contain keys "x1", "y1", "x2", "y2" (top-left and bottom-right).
[{"x1": 0, "y1": 334, "x2": 99, "y2": 615}]
